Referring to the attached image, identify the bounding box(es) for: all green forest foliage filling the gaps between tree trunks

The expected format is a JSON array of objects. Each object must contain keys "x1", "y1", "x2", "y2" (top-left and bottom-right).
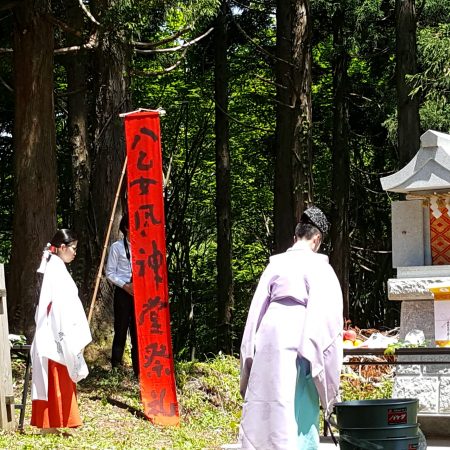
[{"x1": 4, "y1": 0, "x2": 450, "y2": 358}]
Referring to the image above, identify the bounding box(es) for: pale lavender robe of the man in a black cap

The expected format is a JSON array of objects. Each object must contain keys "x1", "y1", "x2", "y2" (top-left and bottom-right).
[{"x1": 239, "y1": 241, "x2": 343, "y2": 450}]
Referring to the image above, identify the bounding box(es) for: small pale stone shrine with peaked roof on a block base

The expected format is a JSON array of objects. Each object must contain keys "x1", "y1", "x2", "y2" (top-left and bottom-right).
[{"x1": 381, "y1": 130, "x2": 450, "y2": 436}]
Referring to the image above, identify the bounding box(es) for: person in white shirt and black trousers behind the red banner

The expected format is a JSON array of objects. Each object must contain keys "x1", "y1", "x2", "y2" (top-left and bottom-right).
[{"x1": 106, "y1": 214, "x2": 139, "y2": 376}]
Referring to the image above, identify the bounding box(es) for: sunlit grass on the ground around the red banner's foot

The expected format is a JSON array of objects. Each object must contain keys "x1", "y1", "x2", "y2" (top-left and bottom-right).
[{"x1": 0, "y1": 355, "x2": 392, "y2": 450}]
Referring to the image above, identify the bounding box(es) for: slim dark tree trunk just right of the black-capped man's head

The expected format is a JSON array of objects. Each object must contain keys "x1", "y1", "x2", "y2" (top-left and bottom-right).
[{"x1": 330, "y1": 6, "x2": 350, "y2": 318}]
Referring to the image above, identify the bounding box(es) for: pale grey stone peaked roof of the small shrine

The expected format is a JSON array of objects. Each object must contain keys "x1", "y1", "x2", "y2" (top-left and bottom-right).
[{"x1": 380, "y1": 130, "x2": 450, "y2": 194}]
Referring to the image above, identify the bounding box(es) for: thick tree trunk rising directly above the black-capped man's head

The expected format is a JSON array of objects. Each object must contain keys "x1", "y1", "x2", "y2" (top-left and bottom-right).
[{"x1": 274, "y1": 0, "x2": 312, "y2": 253}]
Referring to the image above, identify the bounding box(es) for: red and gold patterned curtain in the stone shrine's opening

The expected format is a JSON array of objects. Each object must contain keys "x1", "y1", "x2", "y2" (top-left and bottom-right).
[{"x1": 430, "y1": 197, "x2": 450, "y2": 265}]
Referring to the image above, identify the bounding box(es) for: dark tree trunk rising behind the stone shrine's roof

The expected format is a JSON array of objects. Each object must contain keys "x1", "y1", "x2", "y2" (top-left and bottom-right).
[{"x1": 395, "y1": 0, "x2": 420, "y2": 167}]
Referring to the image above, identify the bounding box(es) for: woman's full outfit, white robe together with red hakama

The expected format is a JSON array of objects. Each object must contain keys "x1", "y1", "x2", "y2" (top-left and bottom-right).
[{"x1": 31, "y1": 255, "x2": 92, "y2": 428}]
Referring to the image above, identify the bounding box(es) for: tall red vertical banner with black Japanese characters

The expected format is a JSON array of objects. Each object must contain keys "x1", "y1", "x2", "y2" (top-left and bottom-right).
[{"x1": 125, "y1": 111, "x2": 179, "y2": 425}]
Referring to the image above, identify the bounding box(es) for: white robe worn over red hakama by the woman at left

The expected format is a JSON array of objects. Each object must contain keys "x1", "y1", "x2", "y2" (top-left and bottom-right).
[{"x1": 31, "y1": 255, "x2": 92, "y2": 400}]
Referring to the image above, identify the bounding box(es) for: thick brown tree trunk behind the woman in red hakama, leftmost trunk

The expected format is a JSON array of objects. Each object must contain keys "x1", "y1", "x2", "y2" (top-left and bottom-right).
[{"x1": 8, "y1": 0, "x2": 57, "y2": 338}]
